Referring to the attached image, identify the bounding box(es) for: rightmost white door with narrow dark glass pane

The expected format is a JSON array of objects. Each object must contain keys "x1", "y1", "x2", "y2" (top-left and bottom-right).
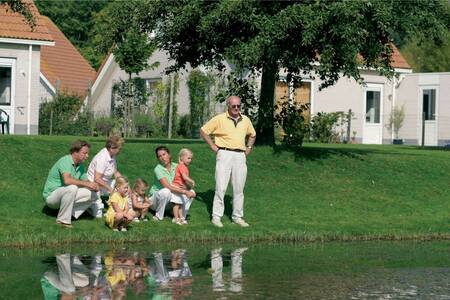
[{"x1": 419, "y1": 87, "x2": 438, "y2": 146}]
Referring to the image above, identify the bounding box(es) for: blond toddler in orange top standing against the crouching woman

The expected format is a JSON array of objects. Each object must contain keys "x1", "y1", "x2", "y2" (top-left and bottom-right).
[{"x1": 170, "y1": 148, "x2": 195, "y2": 225}]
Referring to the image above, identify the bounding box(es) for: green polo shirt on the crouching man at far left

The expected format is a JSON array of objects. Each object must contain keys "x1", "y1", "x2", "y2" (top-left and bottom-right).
[{"x1": 42, "y1": 154, "x2": 87, "y2": 200}]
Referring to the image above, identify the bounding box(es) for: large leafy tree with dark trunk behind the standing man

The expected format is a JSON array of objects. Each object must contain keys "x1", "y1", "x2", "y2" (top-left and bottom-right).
[{"x1": 106, "y1": 0, "x2": 450, "y2": 144}]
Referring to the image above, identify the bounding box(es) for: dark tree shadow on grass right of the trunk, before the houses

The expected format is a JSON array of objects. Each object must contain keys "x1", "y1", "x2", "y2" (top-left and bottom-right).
[{"x1": 273, "y1": 145, "x2": 428, "y2": 162}]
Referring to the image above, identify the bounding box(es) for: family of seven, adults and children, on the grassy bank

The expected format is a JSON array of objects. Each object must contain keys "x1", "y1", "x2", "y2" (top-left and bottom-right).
[{"x1": 43, "y1": 96, "x2": 256, "y2": 231}]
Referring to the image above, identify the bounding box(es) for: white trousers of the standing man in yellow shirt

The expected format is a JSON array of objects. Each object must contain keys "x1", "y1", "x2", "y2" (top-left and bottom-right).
[{"x1": 213, "y1": 150, "x2": 247, "y2": 219}]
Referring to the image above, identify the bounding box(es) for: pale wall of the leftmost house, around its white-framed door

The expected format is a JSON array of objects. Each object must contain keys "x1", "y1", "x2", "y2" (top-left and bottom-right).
[{"x1": 0, "y1": 43, "x2": 40, "y2": 134}]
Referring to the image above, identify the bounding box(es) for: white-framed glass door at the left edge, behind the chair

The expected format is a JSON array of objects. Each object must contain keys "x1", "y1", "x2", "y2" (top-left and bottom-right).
[{"x1": 0, "y1": 58, "x2": 15, "y2": 133}]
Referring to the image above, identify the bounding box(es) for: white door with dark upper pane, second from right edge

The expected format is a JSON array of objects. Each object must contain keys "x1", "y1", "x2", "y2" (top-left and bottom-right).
[{"x1": 363, "y1": 84, "x2": 383, "y2": 144}]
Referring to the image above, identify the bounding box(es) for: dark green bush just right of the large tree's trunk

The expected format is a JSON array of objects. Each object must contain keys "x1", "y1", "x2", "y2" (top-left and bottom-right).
[{"x1": 275, "y1": 101, "x2": 309, "y2": 148}]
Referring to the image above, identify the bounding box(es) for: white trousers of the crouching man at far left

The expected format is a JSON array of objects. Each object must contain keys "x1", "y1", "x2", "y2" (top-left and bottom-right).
[{"x1": 45, "y1": 184, "x2": 95, "y2": 224}]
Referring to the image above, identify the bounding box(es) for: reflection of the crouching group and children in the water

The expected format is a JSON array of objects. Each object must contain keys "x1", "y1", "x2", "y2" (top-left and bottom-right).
[{"x1": 41, "y1": 249, "x2": 192, "y2": 299}]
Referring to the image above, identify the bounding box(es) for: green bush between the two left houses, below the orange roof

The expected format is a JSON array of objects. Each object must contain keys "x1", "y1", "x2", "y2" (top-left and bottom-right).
[{"x1": 39, "y1": 94, "x2": 92, "y2": 135}]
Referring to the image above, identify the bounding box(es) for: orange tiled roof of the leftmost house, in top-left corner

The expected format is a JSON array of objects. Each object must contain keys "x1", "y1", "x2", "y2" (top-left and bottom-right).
[{"x1": 0, "y1": 0, "x2": 53, "y2": 42}]
